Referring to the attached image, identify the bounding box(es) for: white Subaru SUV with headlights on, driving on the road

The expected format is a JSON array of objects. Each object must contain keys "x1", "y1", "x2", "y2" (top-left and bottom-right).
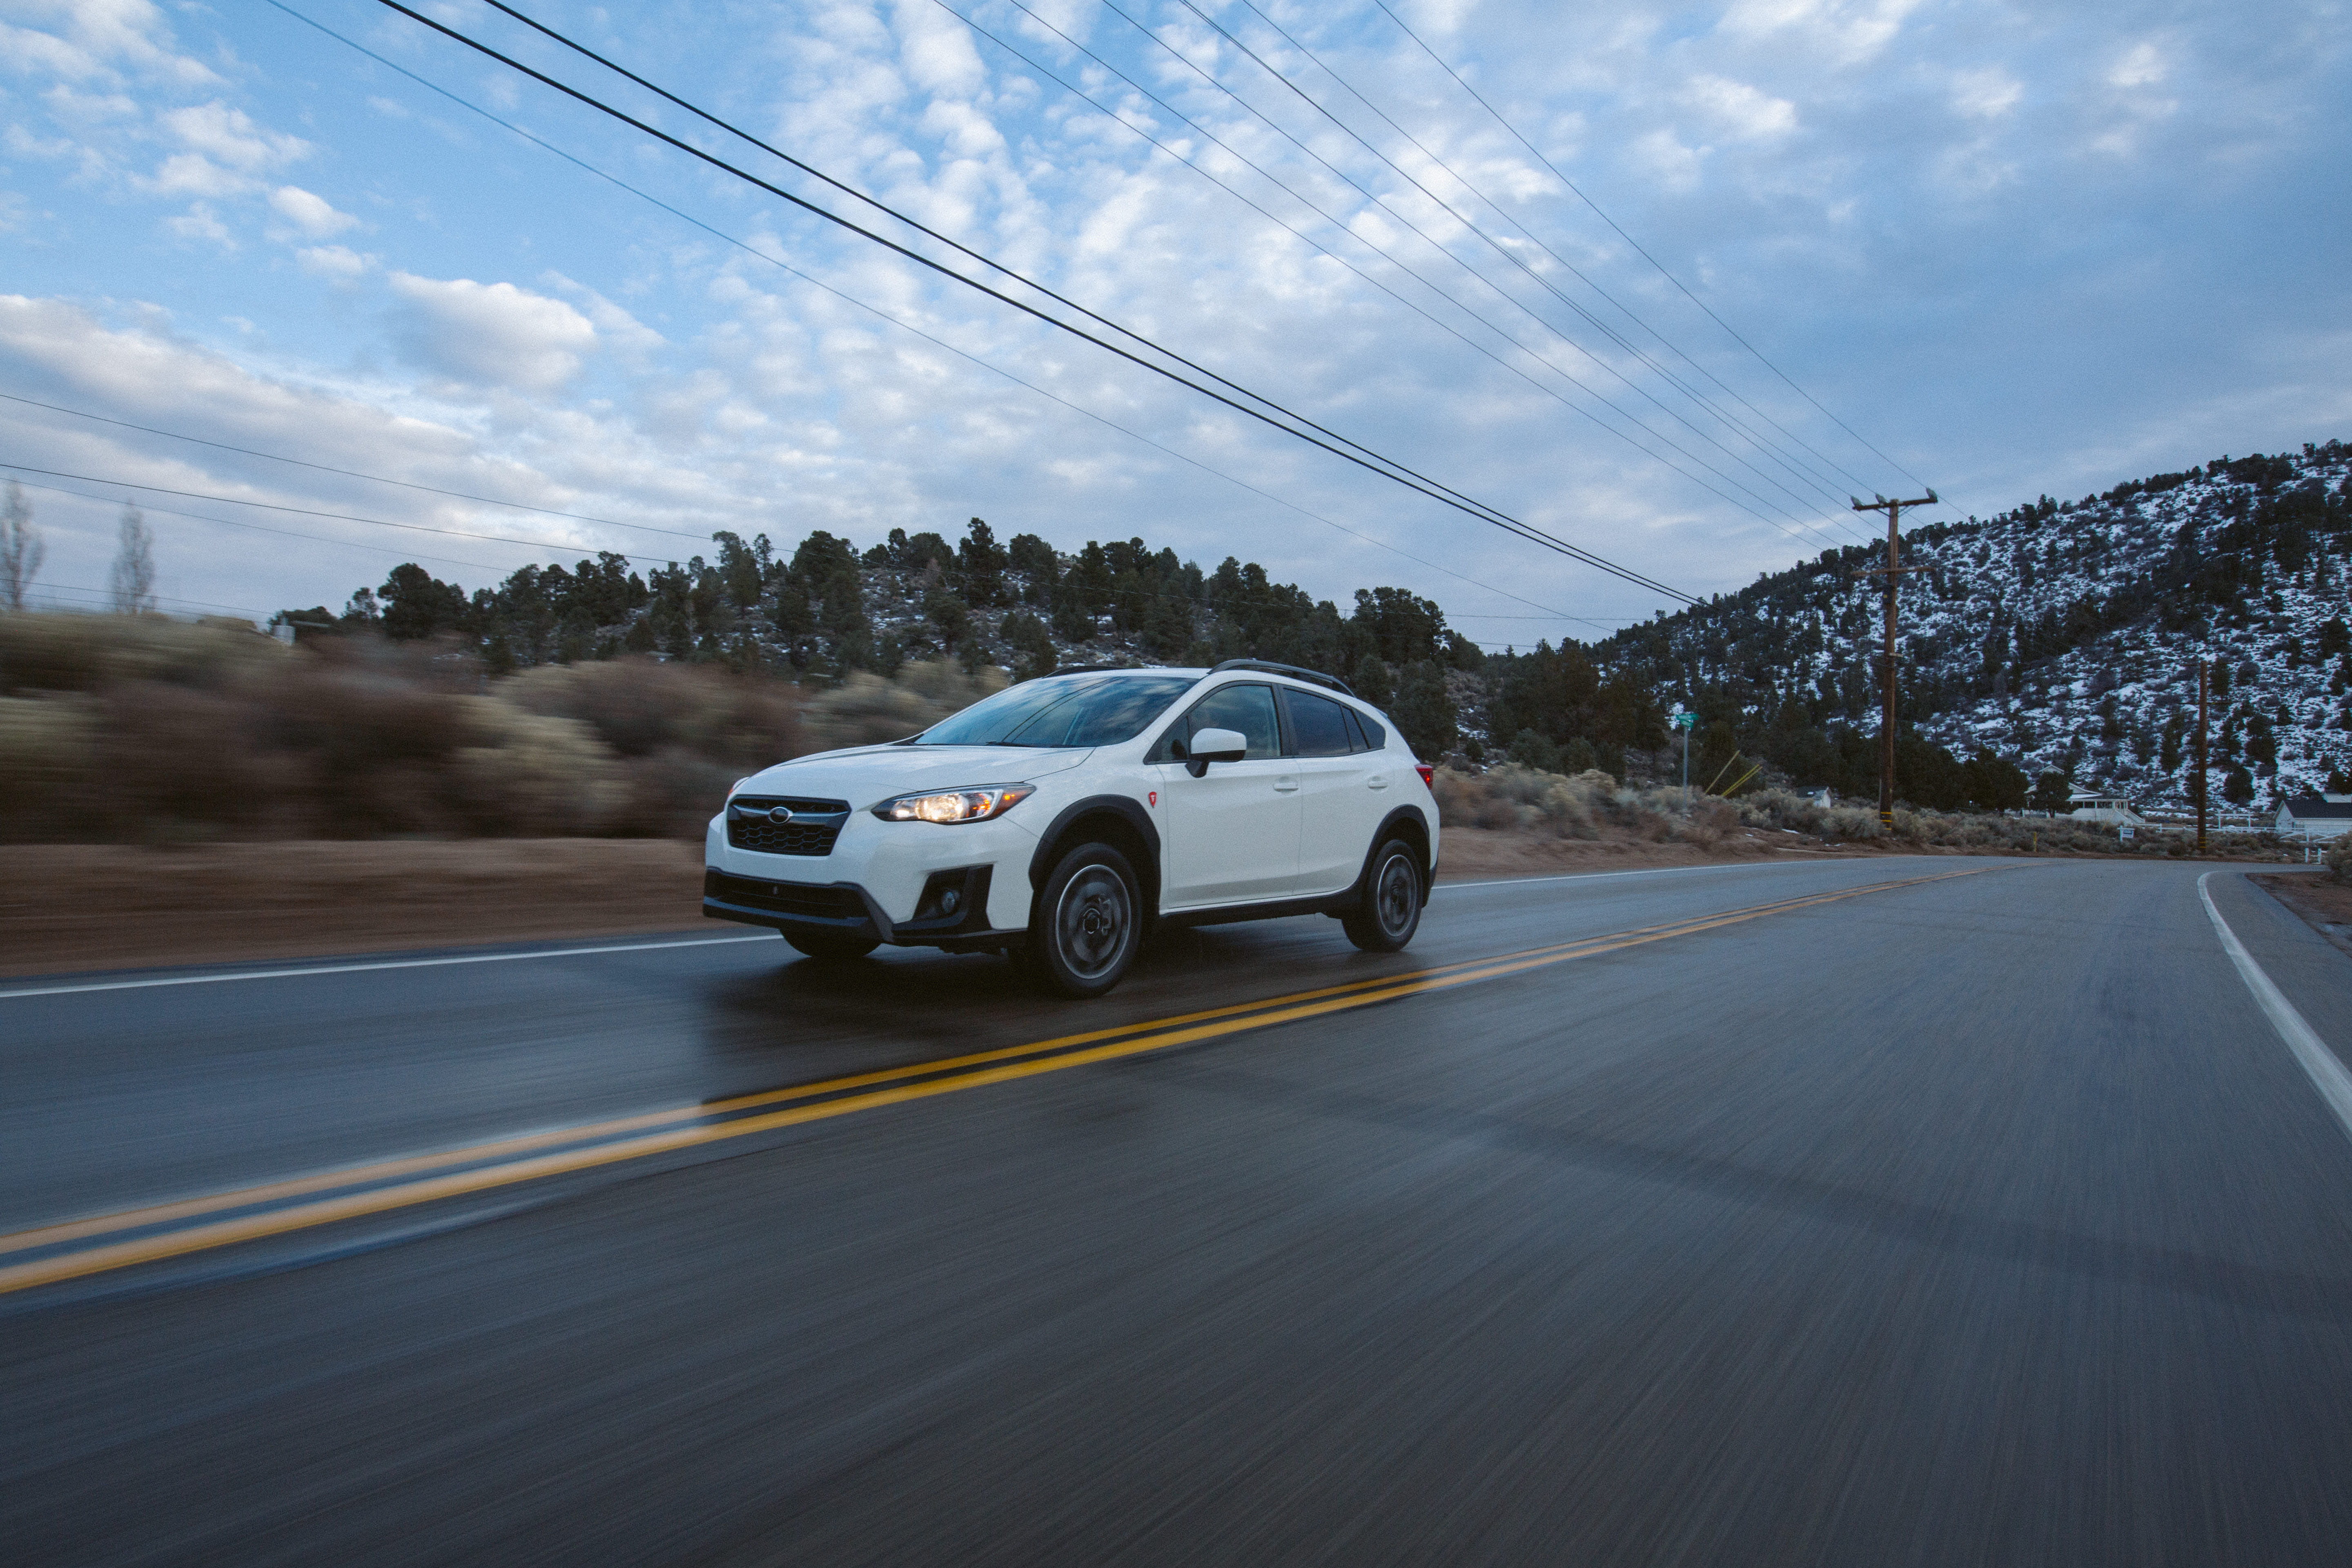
[{"x1": 703, "y1": 661, "x2": 1437, "y2": 997}]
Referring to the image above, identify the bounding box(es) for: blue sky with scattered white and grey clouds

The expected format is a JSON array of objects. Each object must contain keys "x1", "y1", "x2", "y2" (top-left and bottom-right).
[{"x1": 0, "y1": 0, "x2": 2352, "y2": 644}]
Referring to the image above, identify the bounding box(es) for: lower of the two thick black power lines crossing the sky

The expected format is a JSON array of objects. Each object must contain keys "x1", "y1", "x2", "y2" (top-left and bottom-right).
[{"x1": 367, "y1": 0, "x2": 1696, "y2": 604}]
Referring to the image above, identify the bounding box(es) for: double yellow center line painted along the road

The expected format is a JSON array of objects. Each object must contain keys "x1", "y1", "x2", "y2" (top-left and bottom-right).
[{"x1": 0, "y1": 867, "x2": 1994, "y2": 1295}]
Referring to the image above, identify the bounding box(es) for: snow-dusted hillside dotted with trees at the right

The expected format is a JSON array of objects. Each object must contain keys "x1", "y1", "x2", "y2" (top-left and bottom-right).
[{"x1": 1597, "y1": 442, "x2": 2352, "y2": 804}]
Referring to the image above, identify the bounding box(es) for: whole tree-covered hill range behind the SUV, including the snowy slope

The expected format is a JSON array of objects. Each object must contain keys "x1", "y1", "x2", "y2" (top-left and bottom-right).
[{"x1": 253, "y1": 442, "x2": 2352, "y2": 811}]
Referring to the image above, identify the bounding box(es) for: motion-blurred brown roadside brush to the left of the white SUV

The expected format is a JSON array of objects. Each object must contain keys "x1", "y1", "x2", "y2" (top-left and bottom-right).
[{"x1": 0, "y1": 614, "x2": 1004, "y2": 844}]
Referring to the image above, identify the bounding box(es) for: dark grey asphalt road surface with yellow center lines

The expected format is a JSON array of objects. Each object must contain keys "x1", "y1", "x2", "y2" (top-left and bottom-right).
[{"x1": 0, "y1": 858, "x2": 2352, "y2": 1566}]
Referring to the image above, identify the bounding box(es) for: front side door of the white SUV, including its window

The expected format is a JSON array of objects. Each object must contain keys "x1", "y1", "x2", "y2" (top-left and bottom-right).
[{"x1": 1157, "y1": 684, "x2": 1301, "y2": 910}]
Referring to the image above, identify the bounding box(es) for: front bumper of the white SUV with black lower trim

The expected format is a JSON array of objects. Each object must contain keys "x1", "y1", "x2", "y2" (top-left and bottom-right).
[{"x1": 703, "y1": 811, "x2": 1037, "y2": 952}]
